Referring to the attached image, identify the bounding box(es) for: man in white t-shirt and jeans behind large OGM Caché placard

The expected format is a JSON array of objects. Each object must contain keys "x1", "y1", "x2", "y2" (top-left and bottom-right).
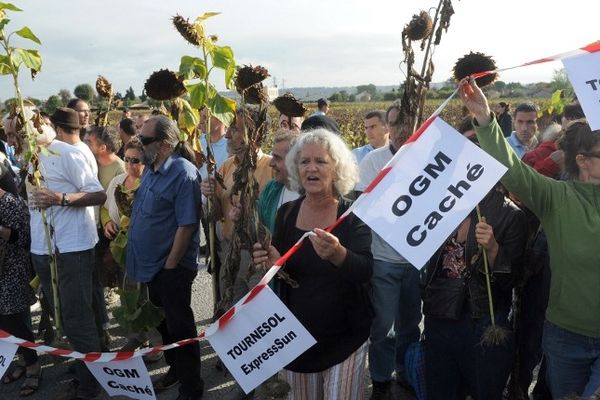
[{"x1": 356, "y1": 102, "x2": 421, "y2": 400}]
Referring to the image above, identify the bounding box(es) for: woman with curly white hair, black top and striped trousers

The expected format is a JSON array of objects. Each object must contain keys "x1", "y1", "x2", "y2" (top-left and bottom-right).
[{"x1": 253, "y1": 129, "x2": 373, "y2": 399}]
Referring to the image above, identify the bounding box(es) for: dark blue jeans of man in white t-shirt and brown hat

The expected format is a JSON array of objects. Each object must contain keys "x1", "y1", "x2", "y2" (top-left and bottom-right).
[{"x1": 31, "y1": 249, "x2": 100, "y2": 399}]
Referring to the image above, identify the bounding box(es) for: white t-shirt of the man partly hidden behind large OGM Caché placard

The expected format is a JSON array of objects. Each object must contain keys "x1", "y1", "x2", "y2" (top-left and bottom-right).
[{"x1": 355, "y1": 145, "x2": 408, "y2": 263}]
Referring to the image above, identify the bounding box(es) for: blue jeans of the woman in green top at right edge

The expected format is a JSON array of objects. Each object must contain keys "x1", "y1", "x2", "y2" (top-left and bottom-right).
[{"x1": 542, "y1": 320, "x2": 600, "y2": 399}]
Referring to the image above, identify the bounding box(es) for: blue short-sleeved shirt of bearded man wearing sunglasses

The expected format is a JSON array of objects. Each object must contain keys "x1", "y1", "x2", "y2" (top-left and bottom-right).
[{"x1": 127, "y1": 154, "x2": 202, "y2": 282}]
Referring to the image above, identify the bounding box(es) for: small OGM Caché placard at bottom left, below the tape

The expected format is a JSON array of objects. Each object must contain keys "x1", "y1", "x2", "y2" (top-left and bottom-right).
[{"x1": 85, "y1": 357, "x2": 156, "y2": 400}]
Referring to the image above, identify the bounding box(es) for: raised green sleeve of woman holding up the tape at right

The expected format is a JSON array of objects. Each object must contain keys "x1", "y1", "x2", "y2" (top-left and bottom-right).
[{"x1": 473, "y1": 115, "x2": 566, "y2": 218}]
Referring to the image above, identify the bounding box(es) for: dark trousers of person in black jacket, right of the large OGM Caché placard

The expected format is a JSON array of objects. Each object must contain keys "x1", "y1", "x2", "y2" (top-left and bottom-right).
[{"x1": 425, "y1": 311, "x2": 514, "y2": 400}]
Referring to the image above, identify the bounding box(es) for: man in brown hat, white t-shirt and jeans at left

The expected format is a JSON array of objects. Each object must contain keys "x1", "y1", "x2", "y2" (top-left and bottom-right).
[{"x1": 28, "y1": 108, "x2": 106, "y2": 400}]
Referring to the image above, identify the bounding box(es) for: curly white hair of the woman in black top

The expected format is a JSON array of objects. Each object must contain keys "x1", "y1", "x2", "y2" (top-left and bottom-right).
[{"x1": 285, "y1": 128, "x2": 358, "y2": 196}]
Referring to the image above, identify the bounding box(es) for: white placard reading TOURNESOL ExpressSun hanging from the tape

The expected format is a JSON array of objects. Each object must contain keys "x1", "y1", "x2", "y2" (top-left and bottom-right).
[{"x1": 208, "y1": 287, "x2": 316, "y2": 393}]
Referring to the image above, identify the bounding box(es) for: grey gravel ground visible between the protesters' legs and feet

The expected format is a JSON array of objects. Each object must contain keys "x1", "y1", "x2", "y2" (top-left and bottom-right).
[{"x1": 0, "y1": 260, "x2": 414, "y2": 400}]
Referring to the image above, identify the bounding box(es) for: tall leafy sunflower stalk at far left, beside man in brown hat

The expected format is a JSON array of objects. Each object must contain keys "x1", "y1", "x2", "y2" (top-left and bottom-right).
[{"x1": 0, "y1": 3, "x2": 62, "y2": 338}]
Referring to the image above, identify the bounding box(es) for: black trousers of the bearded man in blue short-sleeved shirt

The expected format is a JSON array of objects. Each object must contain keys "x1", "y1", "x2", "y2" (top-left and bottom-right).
[{"x1": 148, "y1": 266, "x2": 204, "y2": 397}]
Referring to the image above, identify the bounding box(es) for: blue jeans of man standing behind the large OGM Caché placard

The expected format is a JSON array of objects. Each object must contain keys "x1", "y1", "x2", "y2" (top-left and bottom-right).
[{"x1": 369, "y1": 260, "x2": 421, "y2": 382}]
